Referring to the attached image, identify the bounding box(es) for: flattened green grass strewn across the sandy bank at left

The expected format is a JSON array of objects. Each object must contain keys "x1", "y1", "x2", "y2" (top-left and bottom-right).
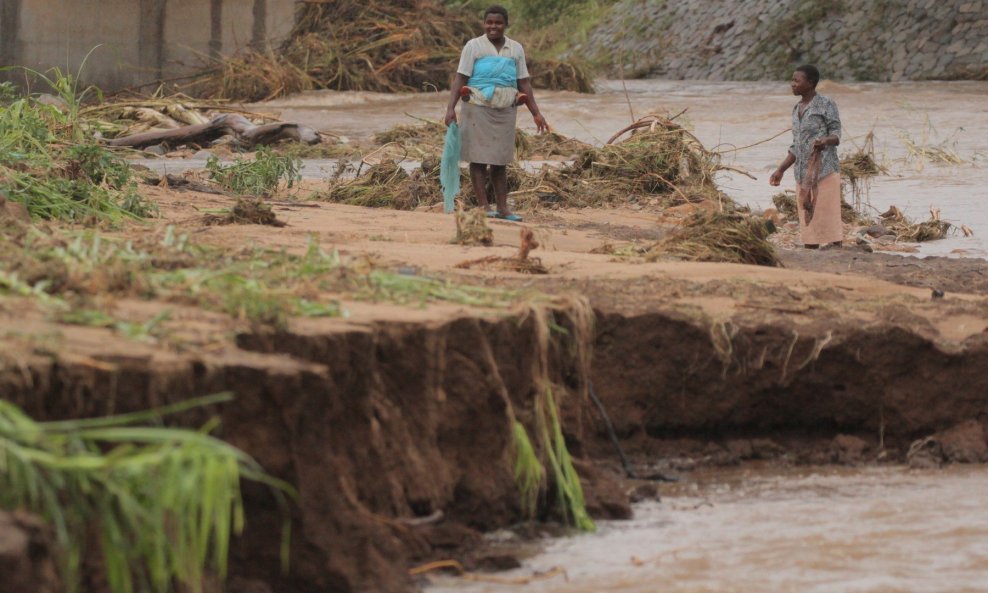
[{"x1": 0, "y1": 225, "x2": 526, "y2": 332}]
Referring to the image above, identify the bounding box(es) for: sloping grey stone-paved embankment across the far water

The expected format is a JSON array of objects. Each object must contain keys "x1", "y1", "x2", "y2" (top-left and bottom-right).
[{"x1": 570, "y1": 0, "x2": 988, "y2": 81}]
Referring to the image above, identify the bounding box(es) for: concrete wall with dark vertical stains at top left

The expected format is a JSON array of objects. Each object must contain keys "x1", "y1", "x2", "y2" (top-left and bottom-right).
[{"x1": 0, "y1": 0, "x2": 295, "y2": 90}]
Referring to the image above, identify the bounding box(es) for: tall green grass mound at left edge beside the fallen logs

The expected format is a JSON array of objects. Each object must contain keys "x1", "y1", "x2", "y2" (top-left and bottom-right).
[{"x1": 0, "y1": 70, "x2": 155, "y2": 223}]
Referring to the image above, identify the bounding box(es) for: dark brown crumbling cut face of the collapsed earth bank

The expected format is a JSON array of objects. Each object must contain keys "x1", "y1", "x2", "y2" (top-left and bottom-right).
[{"x1": 0, "y1": 271, "x2": 988, "y2": 593}]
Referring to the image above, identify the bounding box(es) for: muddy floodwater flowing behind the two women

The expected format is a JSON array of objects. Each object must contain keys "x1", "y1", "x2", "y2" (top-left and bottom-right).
[{"x1": 254, "y1": 80, "x2": 988, "y2": 257}]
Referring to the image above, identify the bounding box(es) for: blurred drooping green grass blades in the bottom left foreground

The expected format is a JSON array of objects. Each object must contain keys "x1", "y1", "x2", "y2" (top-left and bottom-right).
[{"x1": 0, "y1": 394, "x2": 294, "y2": 593}]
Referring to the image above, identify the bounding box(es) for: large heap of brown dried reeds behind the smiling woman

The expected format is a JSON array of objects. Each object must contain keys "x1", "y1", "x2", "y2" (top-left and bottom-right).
[{"x1": 188, "y1": 0, "x2": 592, "y2": 101}]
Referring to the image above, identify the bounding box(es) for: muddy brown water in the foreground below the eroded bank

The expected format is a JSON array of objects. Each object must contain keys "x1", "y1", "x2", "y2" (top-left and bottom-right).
[{"x1": 426, "y1": 466, "x2": 988, "y2": 593}]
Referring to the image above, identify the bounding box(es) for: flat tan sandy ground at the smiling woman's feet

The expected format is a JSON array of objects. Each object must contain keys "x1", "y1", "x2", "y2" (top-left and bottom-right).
[{"x1": 108, "y1": 187, "x2": 988, "y2": 342}]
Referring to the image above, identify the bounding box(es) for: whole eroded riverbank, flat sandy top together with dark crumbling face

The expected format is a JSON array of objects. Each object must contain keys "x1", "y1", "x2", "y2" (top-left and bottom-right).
[{"x1": 0, "y1": 190, "x2": 988, "y2": 592}]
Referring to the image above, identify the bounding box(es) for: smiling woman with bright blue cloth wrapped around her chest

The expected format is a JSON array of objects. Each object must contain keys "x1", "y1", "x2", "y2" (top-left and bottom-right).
[{"x1": 445, "y1": 6, "x2": 549, "y2": 222}]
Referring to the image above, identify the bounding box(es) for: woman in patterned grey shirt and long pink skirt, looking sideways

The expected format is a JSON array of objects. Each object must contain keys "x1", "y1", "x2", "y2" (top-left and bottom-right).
[{"x1": 769, "y1": 65, "x2": 844, "y2": 249}]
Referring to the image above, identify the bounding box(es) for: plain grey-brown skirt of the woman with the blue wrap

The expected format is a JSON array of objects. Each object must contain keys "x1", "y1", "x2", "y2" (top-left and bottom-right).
[{"x1": 459, "y1": 103, "x2": 518, "y2": 165}]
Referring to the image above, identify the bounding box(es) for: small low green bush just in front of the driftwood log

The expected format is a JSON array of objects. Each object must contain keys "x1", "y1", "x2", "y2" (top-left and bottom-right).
[{"x1": 206, "y1": 147, "x2": 302, "y2": 196}]
